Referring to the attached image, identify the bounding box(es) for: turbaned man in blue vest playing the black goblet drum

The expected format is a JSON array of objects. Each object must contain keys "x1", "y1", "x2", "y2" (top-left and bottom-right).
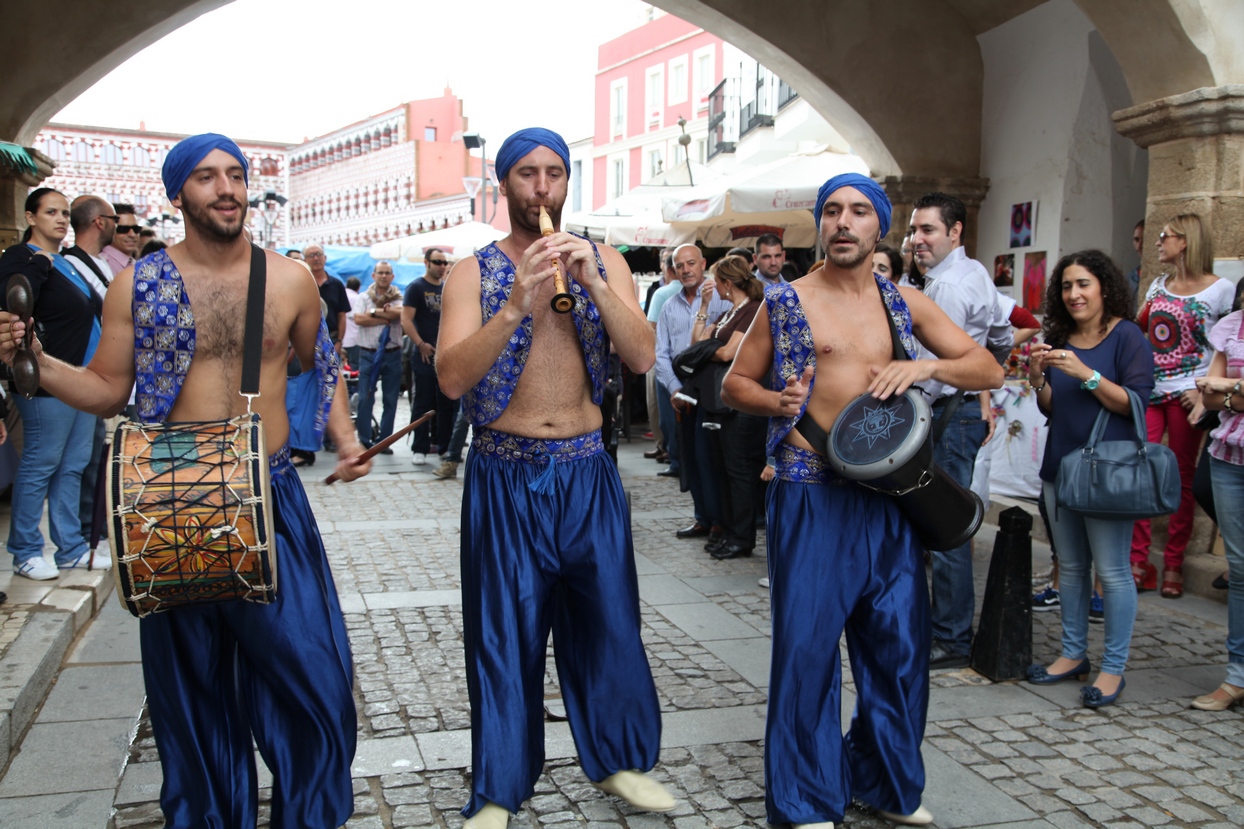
[{"x1": 722, "y1": 173, "x2": 1003, "y2": 827}]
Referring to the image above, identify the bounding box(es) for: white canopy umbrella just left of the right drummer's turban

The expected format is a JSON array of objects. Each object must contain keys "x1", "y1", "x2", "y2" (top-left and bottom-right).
[{"x1": 662, "y1": 149, "x2": 868, "y2": 248}]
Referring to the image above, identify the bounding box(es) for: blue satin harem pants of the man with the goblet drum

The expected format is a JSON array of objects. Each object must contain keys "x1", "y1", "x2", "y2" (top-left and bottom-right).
[{"x1": 765, "y1": 444, "x2": 932, "y2": 824}]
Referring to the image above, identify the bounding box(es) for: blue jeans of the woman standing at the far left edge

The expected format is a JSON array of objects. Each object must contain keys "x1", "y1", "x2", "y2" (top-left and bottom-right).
[{"x1": 9, "y1": 395, "x2": 98, "y2": 565}]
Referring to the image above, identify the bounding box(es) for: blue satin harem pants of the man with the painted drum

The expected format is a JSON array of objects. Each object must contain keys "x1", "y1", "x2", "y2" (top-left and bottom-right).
[{"x1": 139, "y1": 447, "x2": 357, "y2": 829}]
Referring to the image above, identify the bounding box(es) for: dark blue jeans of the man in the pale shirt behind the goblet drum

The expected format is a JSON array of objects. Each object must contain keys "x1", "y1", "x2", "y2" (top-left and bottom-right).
[{"x1": 932, "y1": 401, "x2": 989, "y2": 655}]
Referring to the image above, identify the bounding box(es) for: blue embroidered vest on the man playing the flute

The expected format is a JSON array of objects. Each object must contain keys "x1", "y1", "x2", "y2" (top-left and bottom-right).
[{"x1": 463, "y1": 234, "x2": 610, "y2": 426}]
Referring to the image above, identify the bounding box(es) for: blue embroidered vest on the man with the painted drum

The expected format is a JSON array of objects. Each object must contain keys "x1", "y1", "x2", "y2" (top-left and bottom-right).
[{"x1": 132, "y1": 250, "x2": 338, "y2": 437}]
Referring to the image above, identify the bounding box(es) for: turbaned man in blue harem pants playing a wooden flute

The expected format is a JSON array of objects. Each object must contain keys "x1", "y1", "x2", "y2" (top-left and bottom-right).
[{"x1": 437, "y1": 128, "x2": 675, "y2": 829}]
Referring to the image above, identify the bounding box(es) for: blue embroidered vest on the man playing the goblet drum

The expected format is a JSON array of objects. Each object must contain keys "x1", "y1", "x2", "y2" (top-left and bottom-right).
[{"x1": 765, "y1": 274, "x2": 916, "y2": 456}]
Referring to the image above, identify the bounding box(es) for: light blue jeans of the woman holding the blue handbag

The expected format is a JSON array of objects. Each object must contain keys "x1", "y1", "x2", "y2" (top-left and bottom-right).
[{"x1": 1044, "y1": 482, "x2": 1139, "y2": 676}]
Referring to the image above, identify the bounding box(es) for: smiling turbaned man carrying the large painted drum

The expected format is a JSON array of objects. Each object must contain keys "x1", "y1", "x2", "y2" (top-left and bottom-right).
[{"x1": 0, "y1": 133, "x2": 369, "y2": 829}]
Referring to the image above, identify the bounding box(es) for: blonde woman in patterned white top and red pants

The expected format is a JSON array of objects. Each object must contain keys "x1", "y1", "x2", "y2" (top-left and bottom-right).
[{"x1": 1132, "y1": 213, "x2": 1234, "y2": 599}]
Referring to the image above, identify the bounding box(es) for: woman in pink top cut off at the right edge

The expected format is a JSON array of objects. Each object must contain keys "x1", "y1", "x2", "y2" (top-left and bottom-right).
[{"x1": 1192, "y1": 311, "x2": 1244, "y2": 711}]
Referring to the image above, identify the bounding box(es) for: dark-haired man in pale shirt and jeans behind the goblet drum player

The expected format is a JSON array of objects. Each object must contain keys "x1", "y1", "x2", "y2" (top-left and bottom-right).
[{"x1": 912, "y1": 193, "x2": 1010, "y2": 670}]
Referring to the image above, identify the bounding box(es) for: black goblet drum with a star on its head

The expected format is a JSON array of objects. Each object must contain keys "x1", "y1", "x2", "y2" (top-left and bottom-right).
[{"x1": 825, "y1": 388, "x2": 985, "y2": 550}]
